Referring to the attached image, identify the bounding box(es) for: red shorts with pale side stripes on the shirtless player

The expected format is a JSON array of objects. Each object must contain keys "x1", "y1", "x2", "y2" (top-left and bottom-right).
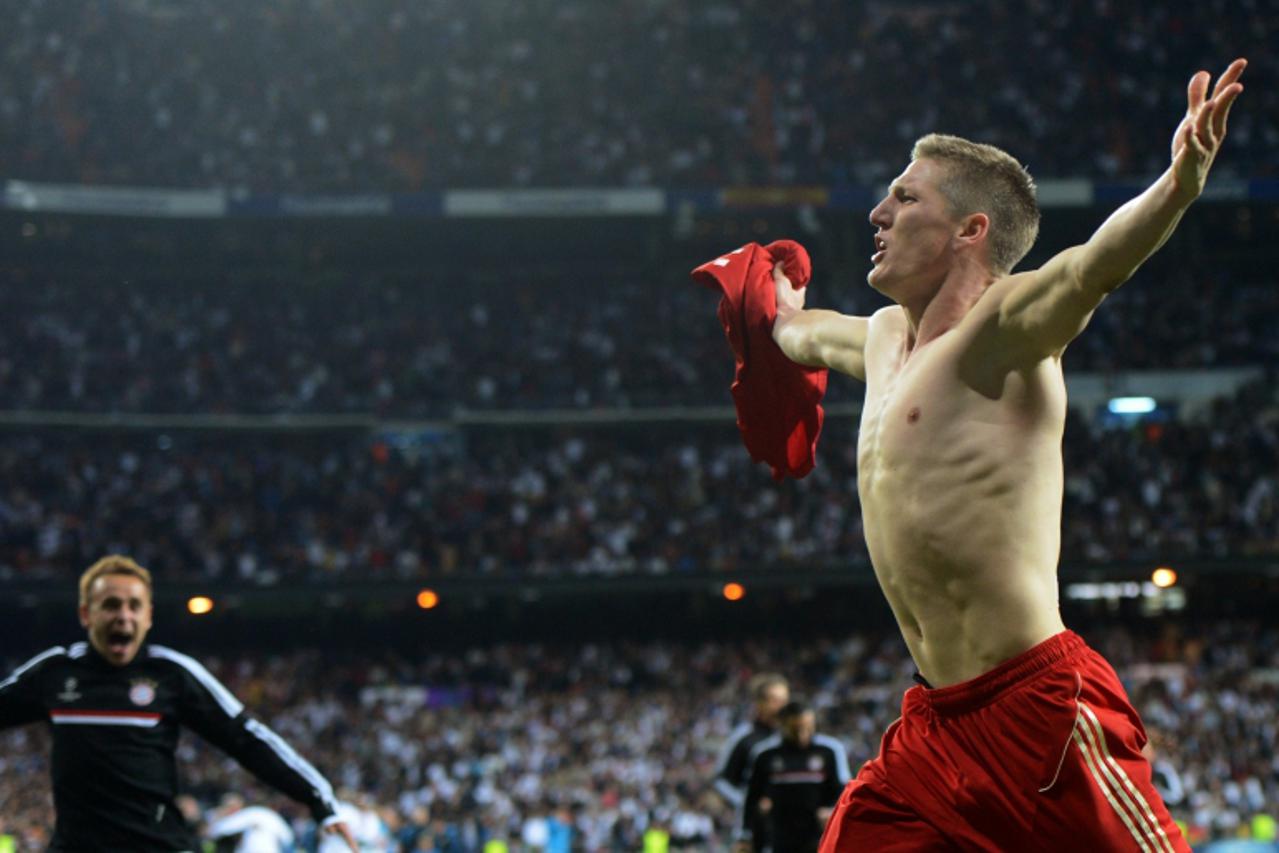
[{"x1": 821, "y1": 630, "x2": 1191, "y2": 853}]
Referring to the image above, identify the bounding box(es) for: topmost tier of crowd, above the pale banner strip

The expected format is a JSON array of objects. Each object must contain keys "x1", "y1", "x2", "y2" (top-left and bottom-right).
[{"x1": 0, "y1": 0, "x2": 1279, "y2": 192}]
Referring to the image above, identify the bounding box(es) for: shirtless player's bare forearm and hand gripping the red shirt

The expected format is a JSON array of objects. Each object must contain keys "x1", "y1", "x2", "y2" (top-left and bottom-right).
[{"x1": 773, "y1": 263, "x2": 870, "y2": 382}]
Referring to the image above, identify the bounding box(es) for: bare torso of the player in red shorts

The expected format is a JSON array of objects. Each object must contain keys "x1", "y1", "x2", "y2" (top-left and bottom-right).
[{"x1": 857, "y1": 294, "x2": 1065, "y2": 687}]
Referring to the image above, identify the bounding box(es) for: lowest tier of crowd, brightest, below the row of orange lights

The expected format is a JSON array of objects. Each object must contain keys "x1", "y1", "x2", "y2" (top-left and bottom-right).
[{"x1": 0, "y1": 622, "x2": 1279, "y2": 853}]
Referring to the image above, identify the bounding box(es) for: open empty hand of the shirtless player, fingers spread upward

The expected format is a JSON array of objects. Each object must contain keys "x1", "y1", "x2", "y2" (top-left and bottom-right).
[{"x1": 1173, "y1": 59, "x2": 1248, "y2": 201}]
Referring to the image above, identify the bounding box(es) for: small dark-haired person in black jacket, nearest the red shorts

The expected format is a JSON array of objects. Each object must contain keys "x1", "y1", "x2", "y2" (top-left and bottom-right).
[{"x1": 738, "y1": 700, "x2": 851, "y2": 853}]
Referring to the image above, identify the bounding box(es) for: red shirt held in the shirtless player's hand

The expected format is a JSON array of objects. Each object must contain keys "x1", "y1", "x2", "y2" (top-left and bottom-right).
[{"x1": 693, "y1": 240, "x2": 828, "y2": 480}]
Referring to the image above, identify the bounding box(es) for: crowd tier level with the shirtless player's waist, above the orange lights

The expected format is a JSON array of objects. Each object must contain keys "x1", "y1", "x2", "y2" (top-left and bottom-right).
[{"x1": 0, "y1": 376, "x2": 1279, "y2": 584}]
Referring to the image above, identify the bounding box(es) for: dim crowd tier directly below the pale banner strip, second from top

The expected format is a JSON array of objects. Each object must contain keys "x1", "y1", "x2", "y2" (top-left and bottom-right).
[{"x1": 0, "y1": 242, "x2": 1279, "y2": 418}]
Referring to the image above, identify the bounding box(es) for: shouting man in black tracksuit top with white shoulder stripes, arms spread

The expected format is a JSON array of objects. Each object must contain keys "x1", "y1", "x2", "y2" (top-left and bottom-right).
[{"x1": 0, "y1": 555, "x2": 358, "y2": 853}]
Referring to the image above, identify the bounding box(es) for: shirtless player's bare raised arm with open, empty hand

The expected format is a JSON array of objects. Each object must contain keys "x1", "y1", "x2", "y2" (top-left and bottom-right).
[{"x1": 999, "y1": 59, "x2": 1247, "y2": 358}]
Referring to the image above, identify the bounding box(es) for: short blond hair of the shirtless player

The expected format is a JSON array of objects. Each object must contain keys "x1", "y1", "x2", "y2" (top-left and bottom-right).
[{"x1": 911, "y1": 133, "x2": 1040, "y2": 275}]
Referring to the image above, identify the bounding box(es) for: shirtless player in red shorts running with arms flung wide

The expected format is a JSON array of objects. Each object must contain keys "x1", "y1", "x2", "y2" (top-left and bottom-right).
[{"x1": 773, "y1": 60, "x2": 1246, "y2": 853}]
